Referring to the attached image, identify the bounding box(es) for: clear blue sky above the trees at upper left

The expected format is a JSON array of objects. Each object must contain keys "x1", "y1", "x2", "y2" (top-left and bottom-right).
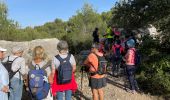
[{"x1": 5, "y1": 0, "x2": 117, "y2": 27}]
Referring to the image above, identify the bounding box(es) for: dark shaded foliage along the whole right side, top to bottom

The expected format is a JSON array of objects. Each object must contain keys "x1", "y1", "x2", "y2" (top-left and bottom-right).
[{"x1": 112, "y1": 0, "x2": 170, "y2": 94}]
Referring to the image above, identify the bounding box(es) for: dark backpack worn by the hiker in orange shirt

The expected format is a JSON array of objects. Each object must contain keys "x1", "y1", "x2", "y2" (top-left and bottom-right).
[{"x1": 91, "y1": 54, "x2": 107, "y2": 76}]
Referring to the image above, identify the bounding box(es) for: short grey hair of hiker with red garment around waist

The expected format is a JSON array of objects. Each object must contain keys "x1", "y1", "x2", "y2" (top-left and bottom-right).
[{"x1": 57, "y1": 40, "x2": 68, "y2": 52}]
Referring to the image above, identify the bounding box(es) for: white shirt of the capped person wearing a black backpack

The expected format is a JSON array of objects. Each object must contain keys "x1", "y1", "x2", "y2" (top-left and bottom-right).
[{"x1": 3, "y1": 55, "x2": 27, "y2": 80}]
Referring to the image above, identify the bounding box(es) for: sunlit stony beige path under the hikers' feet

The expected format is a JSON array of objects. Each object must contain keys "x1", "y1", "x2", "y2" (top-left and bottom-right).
[{"x1": 73, "y1": 67, "x2": 164, "y2": 100}]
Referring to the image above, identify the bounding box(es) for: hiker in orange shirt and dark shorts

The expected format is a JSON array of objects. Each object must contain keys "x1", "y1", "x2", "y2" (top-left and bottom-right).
[{"x1": 84, "y1": 44, "x2": 106, "y2": 100}]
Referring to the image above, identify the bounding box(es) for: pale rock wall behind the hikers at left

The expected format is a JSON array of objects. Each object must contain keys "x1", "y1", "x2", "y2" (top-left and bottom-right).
[{"x1": 0, "y1": 38, "x2": 59, "y2": 62}]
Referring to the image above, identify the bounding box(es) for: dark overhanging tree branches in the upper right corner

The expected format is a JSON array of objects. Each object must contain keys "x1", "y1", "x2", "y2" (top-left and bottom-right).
[{"x1": 112, "y1": 0, "x2": 170, "y2": 30}]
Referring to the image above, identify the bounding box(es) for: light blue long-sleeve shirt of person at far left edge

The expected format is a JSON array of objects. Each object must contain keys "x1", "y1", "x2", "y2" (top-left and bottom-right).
[{"x1": 0, "y1": 62, "x2": 9, "y2": 100}]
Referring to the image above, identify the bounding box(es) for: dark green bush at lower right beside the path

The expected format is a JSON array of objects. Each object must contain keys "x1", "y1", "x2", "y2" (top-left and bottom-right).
[{"x1": 138, "y1": 36, "x2": 170, "y2": 95}]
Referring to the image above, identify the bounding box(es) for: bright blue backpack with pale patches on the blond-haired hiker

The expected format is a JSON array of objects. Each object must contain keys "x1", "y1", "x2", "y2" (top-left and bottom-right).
[{"x1": 28, "y1": 64, "x2": 50, "y2": 100}]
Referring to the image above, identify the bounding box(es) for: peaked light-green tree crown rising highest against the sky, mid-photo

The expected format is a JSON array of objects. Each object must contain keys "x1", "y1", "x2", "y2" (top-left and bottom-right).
[{"x1": 68, "y1": 3, "x2": 106, "y2": 34}]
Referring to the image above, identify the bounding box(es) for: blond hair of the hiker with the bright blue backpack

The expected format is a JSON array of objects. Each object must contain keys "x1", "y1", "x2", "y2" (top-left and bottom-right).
[{"x1": 33, "y1": 46, "x2": 47, "y2": 60}]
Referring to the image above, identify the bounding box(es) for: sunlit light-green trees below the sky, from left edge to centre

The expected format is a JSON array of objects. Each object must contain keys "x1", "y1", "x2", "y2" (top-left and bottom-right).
[{"x1": 0, "y1": 2, "x2": 109, "y2": 53}]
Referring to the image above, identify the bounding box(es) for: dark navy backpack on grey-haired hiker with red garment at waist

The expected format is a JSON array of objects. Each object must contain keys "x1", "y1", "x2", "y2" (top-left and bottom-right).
[{"x1": 55, "y1": 54, "x2": 73, "y2": 84}]
